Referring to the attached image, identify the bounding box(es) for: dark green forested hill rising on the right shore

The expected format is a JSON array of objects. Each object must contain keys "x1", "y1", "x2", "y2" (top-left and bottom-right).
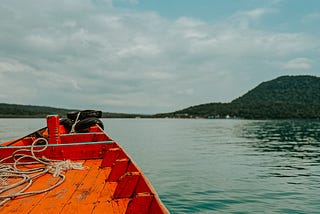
[{"x1": 158, "y1": 75, "x2": 320, "y2": 119}]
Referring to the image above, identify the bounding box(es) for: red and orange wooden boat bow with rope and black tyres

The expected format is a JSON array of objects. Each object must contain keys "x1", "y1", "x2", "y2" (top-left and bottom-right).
[{"x1": 0, "y1": 111, "x2": 168, "y2": 214}]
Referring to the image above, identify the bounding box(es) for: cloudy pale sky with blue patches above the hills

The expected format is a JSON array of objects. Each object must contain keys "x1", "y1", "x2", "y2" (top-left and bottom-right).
[{"x1": 0, "y1": 0, "x2": 320, "y2": 114}]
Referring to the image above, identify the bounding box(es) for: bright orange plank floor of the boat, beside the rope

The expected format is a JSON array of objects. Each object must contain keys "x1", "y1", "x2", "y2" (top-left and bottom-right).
[{"x1": 0, "y1": 160, "x2": 156, "y2": 214}]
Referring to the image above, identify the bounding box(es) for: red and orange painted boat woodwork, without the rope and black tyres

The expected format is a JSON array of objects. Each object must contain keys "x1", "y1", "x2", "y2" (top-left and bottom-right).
[{"x1": 0, "y1": 116, "x2": 168, "y2": 214}]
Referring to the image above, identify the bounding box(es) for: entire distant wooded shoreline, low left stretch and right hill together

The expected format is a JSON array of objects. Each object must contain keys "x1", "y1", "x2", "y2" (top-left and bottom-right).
[{"x1": 0, "y1": 75, "x2": 320, "y2": 120}]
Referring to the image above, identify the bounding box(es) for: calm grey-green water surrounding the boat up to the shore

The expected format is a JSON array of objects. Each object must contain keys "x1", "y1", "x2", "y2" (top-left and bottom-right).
[{"x1": 0, "y1": 119, "x2": 320, "y2": 213}]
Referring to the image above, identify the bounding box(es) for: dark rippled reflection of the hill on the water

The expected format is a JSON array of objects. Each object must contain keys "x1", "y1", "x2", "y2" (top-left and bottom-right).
[{"x1": 241, "y1": 120, "x2": 320, "y2": 162}]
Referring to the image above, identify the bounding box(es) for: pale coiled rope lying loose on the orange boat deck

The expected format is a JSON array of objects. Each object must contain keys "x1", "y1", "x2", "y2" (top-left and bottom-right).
[{"x1": 0, "y1": 138, "x2": 84, "y2": 206}]
